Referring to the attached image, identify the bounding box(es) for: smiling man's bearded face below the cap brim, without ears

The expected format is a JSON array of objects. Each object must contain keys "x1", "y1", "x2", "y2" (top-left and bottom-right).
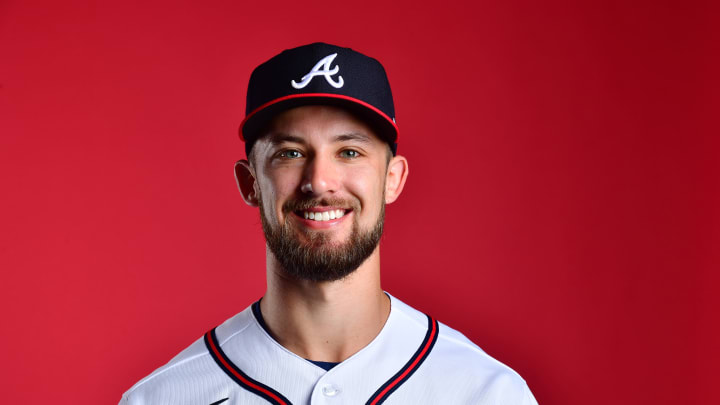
[{"x1": 246, "y1": 106, "x2": 389, "y2": 281}]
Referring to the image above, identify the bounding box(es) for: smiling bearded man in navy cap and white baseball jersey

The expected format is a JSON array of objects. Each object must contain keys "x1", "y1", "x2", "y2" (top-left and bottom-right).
[{"x1": 121, "y1": 43, "x2": 536, "y2": 405}]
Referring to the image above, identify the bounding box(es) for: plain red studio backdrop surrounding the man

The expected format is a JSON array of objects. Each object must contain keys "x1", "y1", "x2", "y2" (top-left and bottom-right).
[{"x1": 0, "y1": 0, "x2": 720, "y2": 405}]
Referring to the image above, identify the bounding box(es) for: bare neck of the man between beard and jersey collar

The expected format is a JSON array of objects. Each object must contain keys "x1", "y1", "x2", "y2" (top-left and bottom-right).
[{"x1": 260, "y1": 248, "x2": 390, "y2": 362}]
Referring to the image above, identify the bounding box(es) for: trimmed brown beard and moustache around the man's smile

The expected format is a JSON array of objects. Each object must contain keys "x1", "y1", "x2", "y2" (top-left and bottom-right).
[{"x1": 259, "y1": 196, "x2": 385, "y2": 282}]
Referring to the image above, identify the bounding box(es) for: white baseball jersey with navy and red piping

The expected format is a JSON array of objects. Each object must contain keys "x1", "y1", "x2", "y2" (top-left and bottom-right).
[{"x1": 120, "y1": 296, "x2": 537, "y2": 405}]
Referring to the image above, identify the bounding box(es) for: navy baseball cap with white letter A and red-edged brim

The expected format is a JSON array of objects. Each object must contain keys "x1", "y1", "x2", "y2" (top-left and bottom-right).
[{"x1": 240, "y1": 42, "x2": 398, "y2": 156}]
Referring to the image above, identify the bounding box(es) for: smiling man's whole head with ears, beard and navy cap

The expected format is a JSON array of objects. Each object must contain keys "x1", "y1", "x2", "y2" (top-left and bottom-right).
[{"x1": 235, "y1": 44, "x2": 408, "y2": 281}]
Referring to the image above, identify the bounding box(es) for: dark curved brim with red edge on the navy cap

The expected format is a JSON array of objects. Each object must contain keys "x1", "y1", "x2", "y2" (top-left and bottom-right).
[{"x1": 240, "y1": 93, "x2": 398, "y2": 155}]
